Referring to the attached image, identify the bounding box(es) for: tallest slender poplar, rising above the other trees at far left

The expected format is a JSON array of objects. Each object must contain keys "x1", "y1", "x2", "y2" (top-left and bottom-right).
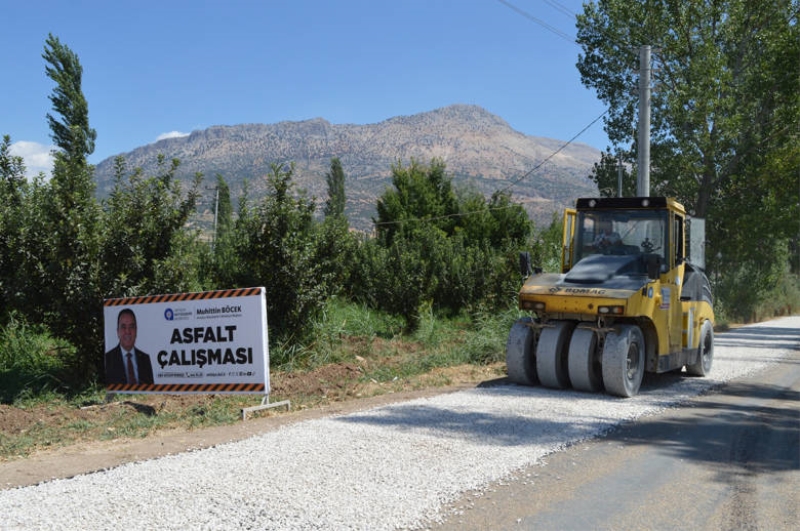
[{"x1": 39, "y1": 34, "x2": 102, "y2": 373}]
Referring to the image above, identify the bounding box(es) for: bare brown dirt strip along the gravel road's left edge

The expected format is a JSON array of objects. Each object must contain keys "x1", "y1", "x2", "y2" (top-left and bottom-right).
[{"x1": 0, "y1": 364, "x2": 499, "y2": 489}]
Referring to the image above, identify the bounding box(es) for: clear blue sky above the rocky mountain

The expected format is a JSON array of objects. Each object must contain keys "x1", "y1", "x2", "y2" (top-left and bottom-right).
[{"x1": 0, "y1": 0, "x2": 608, "y2": 179}]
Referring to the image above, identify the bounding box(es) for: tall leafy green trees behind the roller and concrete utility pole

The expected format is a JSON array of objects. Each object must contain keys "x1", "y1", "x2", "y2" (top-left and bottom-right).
[{"x1": 577, "y1": 0, "x2": 800, "y2": 314}]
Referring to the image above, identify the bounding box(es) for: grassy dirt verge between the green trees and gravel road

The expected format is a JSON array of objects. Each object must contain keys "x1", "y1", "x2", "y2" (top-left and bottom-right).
[{"x1": 0, "y1": 299, "x2": 518, "y2": 461}]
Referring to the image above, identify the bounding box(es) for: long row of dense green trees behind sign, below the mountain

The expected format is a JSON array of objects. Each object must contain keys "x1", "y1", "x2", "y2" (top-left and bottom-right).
[{"x1": 0, "y1": 137, "x2": 533, "y2": 386}]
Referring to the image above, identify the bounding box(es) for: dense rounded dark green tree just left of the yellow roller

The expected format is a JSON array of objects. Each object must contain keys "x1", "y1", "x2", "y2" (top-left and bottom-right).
[{"x1": 368, "y1": 159, "x2": 532, "y2": 330}]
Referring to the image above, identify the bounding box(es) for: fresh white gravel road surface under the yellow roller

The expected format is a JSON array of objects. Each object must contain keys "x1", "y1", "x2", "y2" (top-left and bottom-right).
[{"x1": 0, "y1": 317, "x2": 800, "y2": 530}]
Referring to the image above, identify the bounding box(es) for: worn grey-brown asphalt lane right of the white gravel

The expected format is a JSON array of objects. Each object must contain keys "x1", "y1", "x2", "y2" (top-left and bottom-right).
[{"x1": 430, "y1": 330, "x2": 800, "y2": 531}]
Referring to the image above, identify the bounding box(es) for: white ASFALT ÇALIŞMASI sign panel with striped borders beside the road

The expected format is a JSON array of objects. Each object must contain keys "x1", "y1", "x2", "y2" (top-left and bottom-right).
[{"x1": 103, "y1": 287, "x2": 269, "y2": 395}]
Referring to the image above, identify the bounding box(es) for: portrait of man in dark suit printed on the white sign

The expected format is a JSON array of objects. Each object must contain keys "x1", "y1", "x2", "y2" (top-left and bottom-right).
[{"x1": 105, "y1": 308, "x2": 153, "y2": 385}]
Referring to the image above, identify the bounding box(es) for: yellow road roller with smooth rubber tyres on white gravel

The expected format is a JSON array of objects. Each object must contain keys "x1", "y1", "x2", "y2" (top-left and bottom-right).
[{"x1": 506, "y1": 197, "x2": 714, "y2": 397}]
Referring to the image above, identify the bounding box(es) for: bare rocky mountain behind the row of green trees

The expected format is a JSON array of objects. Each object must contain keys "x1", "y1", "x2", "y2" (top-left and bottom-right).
[{"x1": 95, "y1": 105, "x2": 600, "y2": 230}]
